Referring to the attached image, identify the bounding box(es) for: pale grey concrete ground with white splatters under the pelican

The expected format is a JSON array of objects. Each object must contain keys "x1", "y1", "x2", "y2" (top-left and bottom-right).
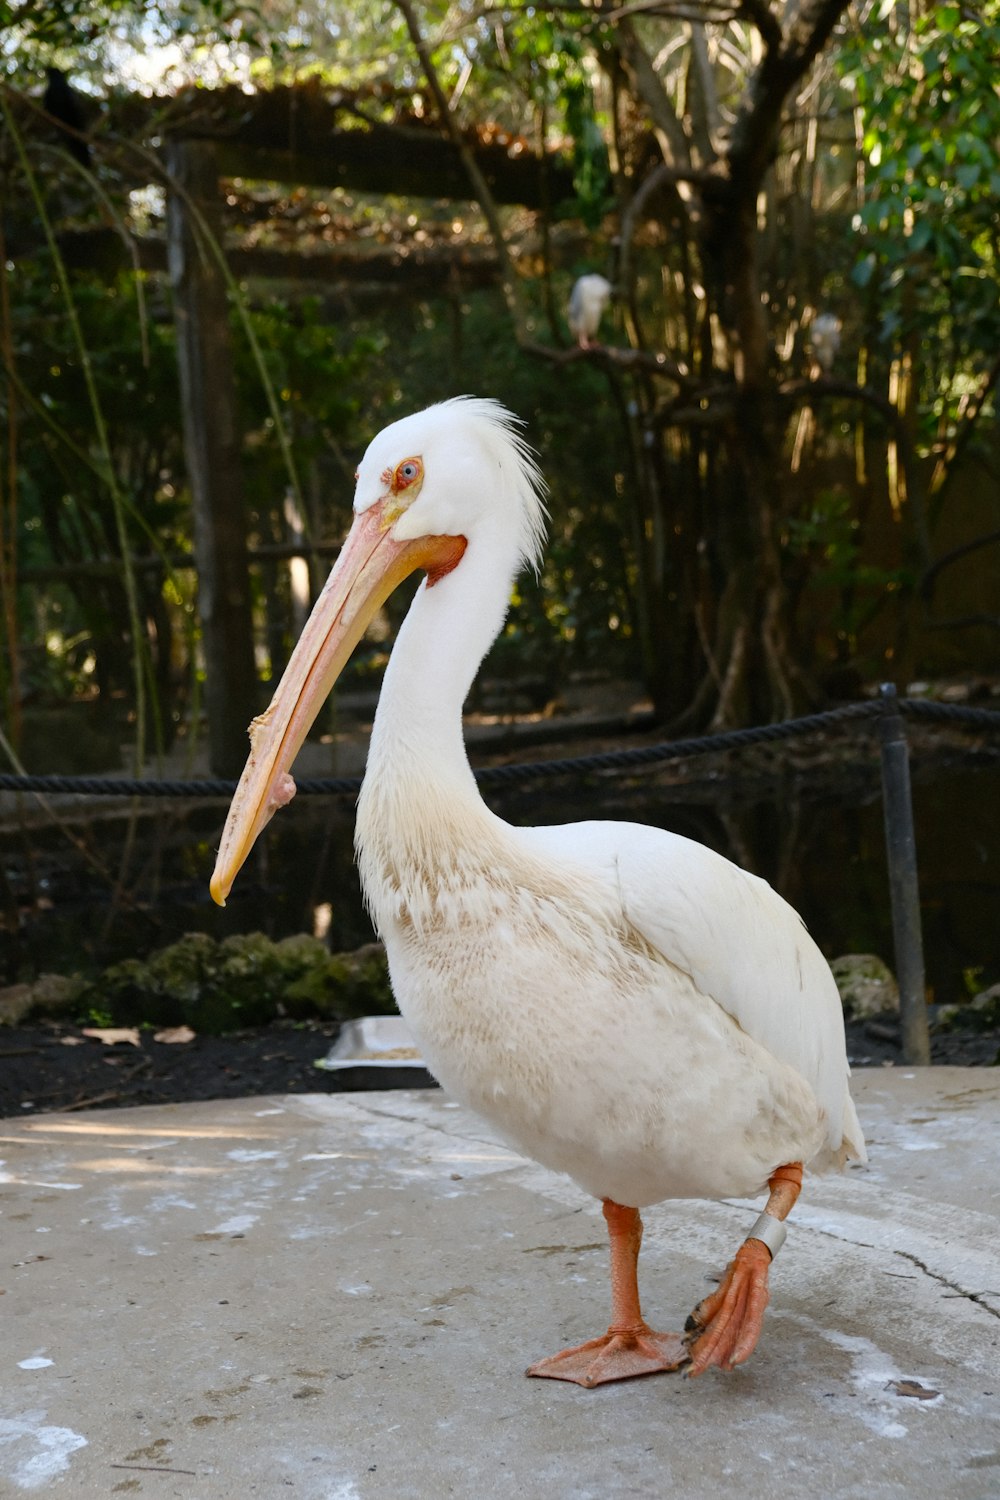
[{"x1": 0, "y1": 1068, "x2": 1000, "y2": 1500}]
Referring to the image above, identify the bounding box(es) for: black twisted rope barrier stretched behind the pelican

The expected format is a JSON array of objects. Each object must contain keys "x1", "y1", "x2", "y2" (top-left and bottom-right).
[{"x1": 0, "y1": 698, "x2": 1000, "y2": 800}]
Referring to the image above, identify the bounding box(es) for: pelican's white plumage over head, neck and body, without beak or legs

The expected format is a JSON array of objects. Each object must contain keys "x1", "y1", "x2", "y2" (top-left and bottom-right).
[{"x1": 355, "y1": 401, "x2": 864, "y2": 1208}]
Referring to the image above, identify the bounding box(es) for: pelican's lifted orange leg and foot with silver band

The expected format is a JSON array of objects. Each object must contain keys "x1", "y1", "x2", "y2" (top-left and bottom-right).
[{"x1": 685, "y1": 1161, "x2": 802, "y2": 1376}]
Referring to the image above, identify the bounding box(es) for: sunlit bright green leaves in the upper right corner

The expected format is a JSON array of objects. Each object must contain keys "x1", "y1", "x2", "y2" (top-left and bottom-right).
[{"x1": 838, "y1": 0, "x2": 1000, "y2": 446}]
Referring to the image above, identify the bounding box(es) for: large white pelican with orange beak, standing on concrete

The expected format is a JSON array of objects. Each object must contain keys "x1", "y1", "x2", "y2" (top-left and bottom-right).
[{"x1": 211, "y1": 398, "x2": 865, "y2": 1386}]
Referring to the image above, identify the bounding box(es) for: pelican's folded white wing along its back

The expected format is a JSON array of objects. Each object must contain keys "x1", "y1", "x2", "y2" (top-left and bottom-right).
[{"x1": 520, "y1": 822, "x2": 864, "y2": 1160}]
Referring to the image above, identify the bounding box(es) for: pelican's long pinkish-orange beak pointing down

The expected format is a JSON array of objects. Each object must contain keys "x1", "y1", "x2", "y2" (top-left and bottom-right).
[{"x1": 210, "y1": 497, "x2": 465, "y2": 906}]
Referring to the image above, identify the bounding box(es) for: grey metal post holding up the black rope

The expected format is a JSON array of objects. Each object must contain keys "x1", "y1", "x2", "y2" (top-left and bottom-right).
[{"x1": 879, "y1": 683, "x2": 931, "y2": 1064}]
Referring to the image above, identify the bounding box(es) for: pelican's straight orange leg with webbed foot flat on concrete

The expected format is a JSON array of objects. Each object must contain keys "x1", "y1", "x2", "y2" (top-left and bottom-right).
[{"x1": 528, "y1": 1199, "x2": 688, "y2": 1386}]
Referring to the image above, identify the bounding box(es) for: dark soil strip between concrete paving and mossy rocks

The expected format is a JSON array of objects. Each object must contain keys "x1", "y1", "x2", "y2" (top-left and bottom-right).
[{"x1": 0, "y1": 1020, "x2": 1000, "y2": 1118}]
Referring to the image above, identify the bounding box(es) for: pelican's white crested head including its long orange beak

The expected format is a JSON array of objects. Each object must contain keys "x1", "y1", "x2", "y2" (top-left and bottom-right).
[{"x1": 211, "y1": 396, "x2": 544, "y2": 906}]
